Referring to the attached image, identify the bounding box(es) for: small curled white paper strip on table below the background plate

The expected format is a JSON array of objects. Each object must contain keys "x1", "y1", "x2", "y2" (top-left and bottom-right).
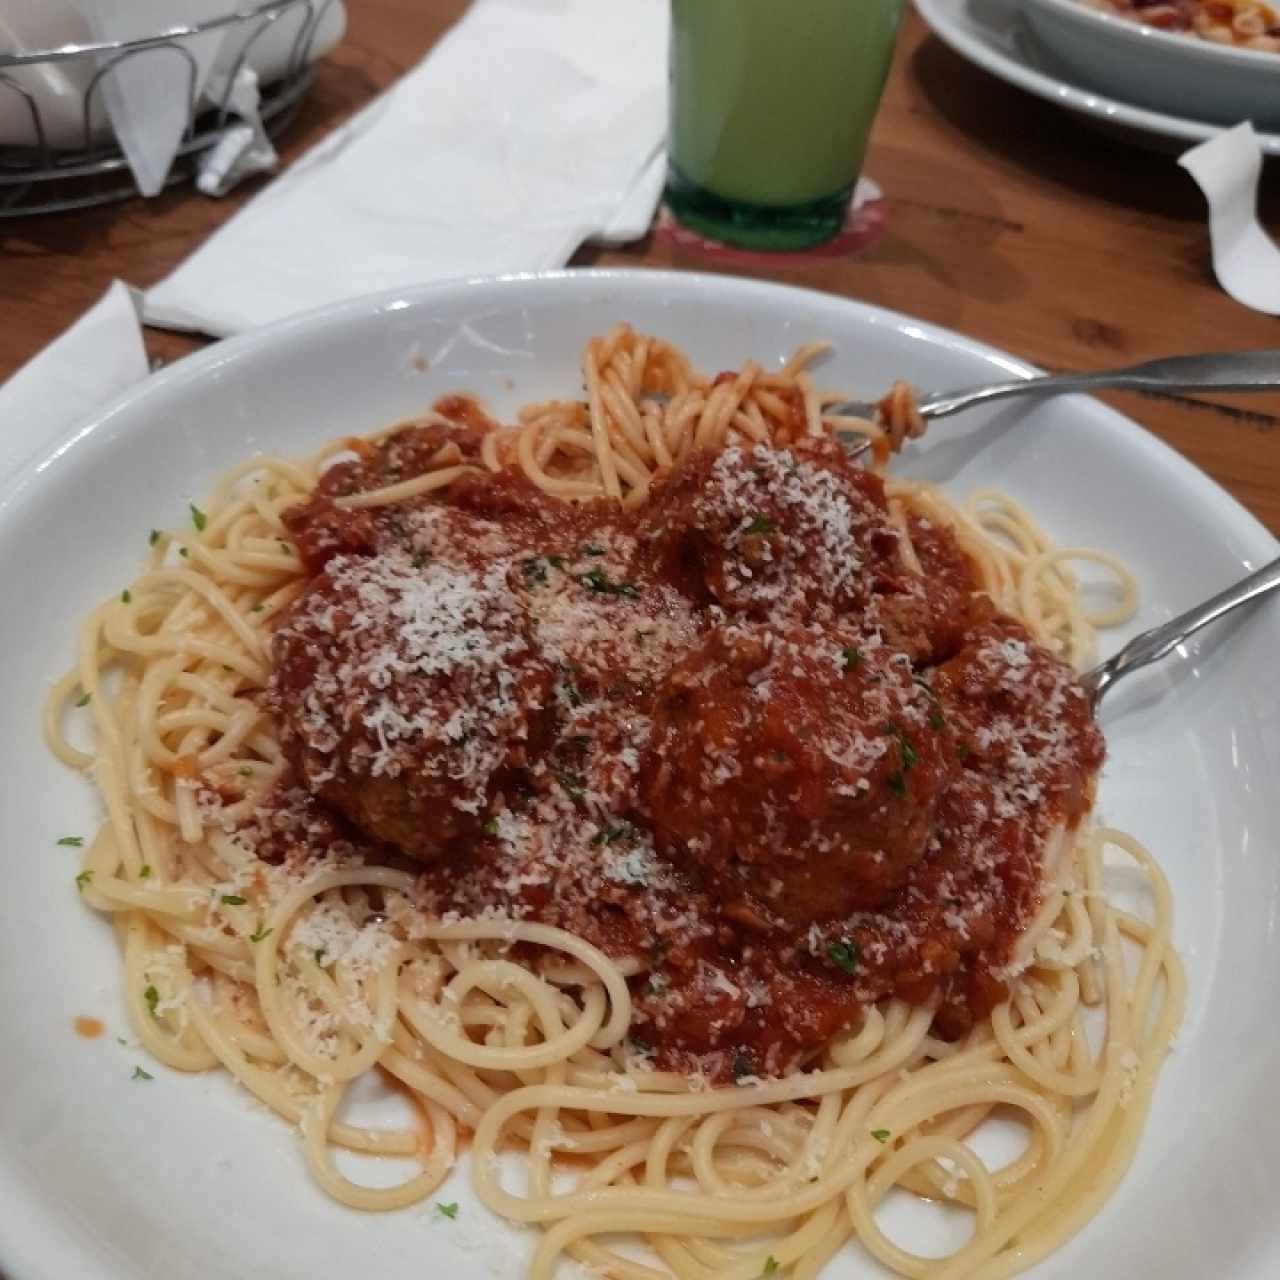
[{"x1": 1178, "y1": 122, "x2": 1280, "y2": 315}]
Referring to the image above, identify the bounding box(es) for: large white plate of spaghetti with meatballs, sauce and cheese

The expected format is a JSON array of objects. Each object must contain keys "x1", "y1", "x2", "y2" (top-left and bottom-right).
[{"x1": 0, "y1": 271, "x2": 1280, "y2": 1280}]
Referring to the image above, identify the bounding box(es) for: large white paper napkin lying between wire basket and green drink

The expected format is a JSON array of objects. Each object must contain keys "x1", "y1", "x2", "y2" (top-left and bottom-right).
[{"x1": 145, "y1": 0, "x2": 668, "y2": 335}]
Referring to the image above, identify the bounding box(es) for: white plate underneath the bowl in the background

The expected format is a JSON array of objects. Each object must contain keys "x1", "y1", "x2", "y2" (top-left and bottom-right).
[{"x1": 915, "y1": 0, "x2": 1280, "y2": 155}]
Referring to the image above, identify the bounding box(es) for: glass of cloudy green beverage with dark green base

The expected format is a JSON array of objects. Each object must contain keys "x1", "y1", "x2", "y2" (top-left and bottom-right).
[{"x1": 667, "y1": 0, "x2": 905, "y2": 248}]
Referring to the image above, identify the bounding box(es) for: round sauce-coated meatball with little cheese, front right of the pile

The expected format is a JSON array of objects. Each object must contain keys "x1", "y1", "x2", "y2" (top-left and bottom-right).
[{"x1": 640, "y1": 625, "x2": 952, "y2": 927}]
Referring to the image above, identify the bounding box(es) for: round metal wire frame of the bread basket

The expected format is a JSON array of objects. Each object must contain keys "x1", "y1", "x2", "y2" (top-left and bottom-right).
[{"x1": 0, "y1": 0, "x2": 335, "y2": 218}]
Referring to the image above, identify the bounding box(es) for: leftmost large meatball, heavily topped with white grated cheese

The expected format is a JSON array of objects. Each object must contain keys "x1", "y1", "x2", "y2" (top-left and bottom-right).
[{"x1": 266, "y1": 553, "x2": 552, "y2": 861}]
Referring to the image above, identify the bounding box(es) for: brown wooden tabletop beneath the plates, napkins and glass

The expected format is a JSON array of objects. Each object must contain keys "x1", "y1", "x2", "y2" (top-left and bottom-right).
[{"x1": 0, "y1": 0, "x2": 1280, "y2": 534}]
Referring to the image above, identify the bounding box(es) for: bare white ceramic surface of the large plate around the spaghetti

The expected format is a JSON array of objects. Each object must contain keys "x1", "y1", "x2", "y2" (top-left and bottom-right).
[{"x1": 0, "y1": 264, "x2": 1280, "y2": 1280}]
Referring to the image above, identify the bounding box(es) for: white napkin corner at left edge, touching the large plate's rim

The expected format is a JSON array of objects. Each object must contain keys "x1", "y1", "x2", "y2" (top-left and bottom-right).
[{"x1": 0, "y1": 280, "x2": 150, "y2": 483}]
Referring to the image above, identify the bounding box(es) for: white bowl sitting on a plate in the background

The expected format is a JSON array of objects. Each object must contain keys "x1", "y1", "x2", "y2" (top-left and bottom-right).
[{"x1": 1023, "y1": 0, "x2": 1280, "y2": 129}]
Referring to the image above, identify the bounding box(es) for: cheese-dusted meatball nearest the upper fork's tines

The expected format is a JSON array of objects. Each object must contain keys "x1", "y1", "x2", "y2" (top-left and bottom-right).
[{"x1": 639, "y1": 438, "x2": 905, "y2": 621}]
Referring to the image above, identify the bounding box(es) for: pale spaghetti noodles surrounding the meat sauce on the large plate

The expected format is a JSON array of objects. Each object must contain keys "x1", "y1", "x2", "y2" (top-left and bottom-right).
[{"x1": 45, "y1": 328, "x2": 1184, "y2": 1280}]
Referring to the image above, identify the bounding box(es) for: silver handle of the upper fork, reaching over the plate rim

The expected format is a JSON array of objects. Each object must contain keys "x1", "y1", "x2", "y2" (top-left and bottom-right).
[{"x1": 919, "y1": 351, "x2": 1280, "y2": 419}]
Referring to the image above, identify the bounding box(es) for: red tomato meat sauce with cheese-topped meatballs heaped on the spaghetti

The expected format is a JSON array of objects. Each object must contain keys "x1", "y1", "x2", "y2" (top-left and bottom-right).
[{"x1": 254, "y1": 398, "x2": 1103, "y2": 1082}]
